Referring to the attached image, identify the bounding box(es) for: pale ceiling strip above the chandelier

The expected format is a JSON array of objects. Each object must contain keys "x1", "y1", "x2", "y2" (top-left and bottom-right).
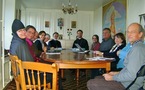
[{"x1": 21, "y1": 0, "x2": 112, "y2": 11}]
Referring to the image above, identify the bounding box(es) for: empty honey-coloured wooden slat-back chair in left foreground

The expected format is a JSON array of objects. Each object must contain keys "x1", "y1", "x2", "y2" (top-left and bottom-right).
[{"x1": 10, "y1": 55, "x2": 58, "y2": 90}]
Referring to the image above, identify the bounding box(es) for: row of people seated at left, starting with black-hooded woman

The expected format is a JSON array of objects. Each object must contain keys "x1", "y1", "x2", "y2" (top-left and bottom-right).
[{"x1": 10, "y1": 19, "x2": 63, "y2": 90}]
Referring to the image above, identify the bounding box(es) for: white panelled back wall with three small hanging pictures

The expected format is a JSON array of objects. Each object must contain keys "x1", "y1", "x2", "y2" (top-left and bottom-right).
[{"x1": 22, "y1": 8, "x2": 94, "y2": 48}]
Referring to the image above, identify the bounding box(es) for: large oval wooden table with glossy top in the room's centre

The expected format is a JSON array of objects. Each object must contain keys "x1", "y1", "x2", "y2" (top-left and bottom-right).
[{"x1": 45, "y1": 50, "x2": 112, "y2": 80}]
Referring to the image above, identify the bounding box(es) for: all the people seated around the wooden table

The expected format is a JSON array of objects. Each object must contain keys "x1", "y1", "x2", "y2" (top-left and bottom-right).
[{"x1": 10, "y1": 19, "x2": 145, "y2": 90}]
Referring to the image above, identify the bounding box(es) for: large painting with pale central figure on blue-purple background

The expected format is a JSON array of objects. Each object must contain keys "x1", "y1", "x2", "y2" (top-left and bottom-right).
[{"x1": 103, "y1": 0, "x2": 127, "y2": 36}]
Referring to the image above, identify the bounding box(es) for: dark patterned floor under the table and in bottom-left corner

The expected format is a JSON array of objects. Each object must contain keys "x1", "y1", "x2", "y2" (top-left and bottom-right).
[{"x1": 3, "y1": 70, "x2": 90, "y2": 90}]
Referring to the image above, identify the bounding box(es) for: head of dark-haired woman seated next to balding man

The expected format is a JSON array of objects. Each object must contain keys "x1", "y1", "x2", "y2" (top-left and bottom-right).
[{"x1": 114, "y1": 33, "x2": 126, "y2": 44}]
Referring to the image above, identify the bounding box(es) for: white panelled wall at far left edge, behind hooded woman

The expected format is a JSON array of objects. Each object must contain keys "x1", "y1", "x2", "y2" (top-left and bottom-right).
[{"x1": 0, "y1": 0, "x2": 15, "y2": 89}]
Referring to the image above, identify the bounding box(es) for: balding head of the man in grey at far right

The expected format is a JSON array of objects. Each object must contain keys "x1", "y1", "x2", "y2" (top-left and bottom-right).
[{"x1": 127, "y1": 23, "x2": 144, "y2": 44}]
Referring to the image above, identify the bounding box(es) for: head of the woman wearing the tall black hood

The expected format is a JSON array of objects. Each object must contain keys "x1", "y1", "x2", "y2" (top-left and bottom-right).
[{"x1": 12, "y1": 19, "x2": 26, "y2": 39}]
